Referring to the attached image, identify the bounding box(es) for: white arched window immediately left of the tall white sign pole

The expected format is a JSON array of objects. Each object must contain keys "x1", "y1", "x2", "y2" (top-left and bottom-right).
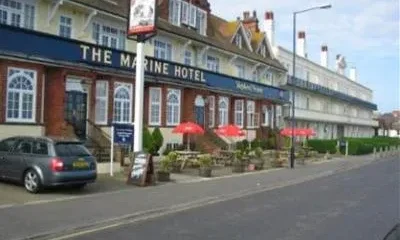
[{"x1": 114, "y1": 85, "x2": 132, "y2": 123}]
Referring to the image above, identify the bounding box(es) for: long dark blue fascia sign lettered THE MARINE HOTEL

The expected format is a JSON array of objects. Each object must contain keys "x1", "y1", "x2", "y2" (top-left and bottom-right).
[{"x1": 0, "y1": 24, "x2": 289, "y2": 101}]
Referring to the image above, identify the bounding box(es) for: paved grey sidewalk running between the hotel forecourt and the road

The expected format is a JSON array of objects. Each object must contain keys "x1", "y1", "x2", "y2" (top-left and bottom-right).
[{"x1": 0, "y1": 156, "x2": 394, "y2": 239}]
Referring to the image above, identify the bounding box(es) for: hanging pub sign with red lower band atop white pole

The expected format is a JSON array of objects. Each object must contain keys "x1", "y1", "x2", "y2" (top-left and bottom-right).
[{"x1": 128, "y1": 0, "x2": 157, "y2": 37}]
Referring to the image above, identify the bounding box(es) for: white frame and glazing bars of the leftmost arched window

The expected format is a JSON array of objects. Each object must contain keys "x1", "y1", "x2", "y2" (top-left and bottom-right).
[{"x1": 6, "y1": 67, "x2": 37, "y2": 123}]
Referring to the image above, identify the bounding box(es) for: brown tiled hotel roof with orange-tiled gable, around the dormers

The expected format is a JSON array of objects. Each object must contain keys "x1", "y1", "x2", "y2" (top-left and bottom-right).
[{"x1": 71, "y1": 0, "x2": 286, "y2": 72}]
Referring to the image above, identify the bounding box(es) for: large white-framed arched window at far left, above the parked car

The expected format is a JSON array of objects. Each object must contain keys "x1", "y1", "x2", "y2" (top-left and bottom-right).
[{"x1": 7, "y1": 68, "x2": 36, "y2": 122}]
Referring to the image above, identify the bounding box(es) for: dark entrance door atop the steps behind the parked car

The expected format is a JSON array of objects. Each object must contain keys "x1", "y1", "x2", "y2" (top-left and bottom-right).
[{"x1": 64, "y1": 91, "x2": 87, "y2": 139}]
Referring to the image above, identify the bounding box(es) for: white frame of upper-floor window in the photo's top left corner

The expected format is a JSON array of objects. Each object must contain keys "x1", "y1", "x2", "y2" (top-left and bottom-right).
[{"x1": 0, "y1": 0, "x2": 36, "y2": 30}]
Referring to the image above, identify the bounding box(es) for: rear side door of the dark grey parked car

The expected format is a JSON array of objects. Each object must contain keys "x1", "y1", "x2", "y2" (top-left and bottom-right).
[{"x1": 5, "y1": 139, "x2": 33, "y2": 181}]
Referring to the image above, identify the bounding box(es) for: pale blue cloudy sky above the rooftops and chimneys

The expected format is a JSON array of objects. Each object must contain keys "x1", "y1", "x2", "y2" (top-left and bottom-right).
[{"x1": 209, "y1": 0, "x2": 400, "y2": 112}]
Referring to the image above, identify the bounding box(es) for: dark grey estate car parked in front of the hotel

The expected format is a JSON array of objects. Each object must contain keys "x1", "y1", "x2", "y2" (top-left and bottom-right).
[{"x1": 0, "y1": 136, "x2": 97, "y2": 193}]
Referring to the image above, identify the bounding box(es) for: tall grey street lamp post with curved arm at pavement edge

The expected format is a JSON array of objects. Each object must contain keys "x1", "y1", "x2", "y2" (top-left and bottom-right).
[{"x1": 290, "y1": 4, "x2": 332, "y2": 168}]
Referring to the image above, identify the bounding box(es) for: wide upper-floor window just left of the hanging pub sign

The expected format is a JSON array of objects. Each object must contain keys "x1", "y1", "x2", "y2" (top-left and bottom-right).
[{"x1": 92, "y1": 22, "x2": 126, "y2": 50}]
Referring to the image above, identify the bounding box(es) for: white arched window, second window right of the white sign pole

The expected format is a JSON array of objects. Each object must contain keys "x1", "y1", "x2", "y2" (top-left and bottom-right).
[{"x1": 167, "y1": 89, "x2": 181, "y2": 126}]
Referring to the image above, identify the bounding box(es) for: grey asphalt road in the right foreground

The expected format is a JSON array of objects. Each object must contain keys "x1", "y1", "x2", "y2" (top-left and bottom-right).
[{"x1": 74, "y1": 159, "x2": 400, "y2": 240}]
